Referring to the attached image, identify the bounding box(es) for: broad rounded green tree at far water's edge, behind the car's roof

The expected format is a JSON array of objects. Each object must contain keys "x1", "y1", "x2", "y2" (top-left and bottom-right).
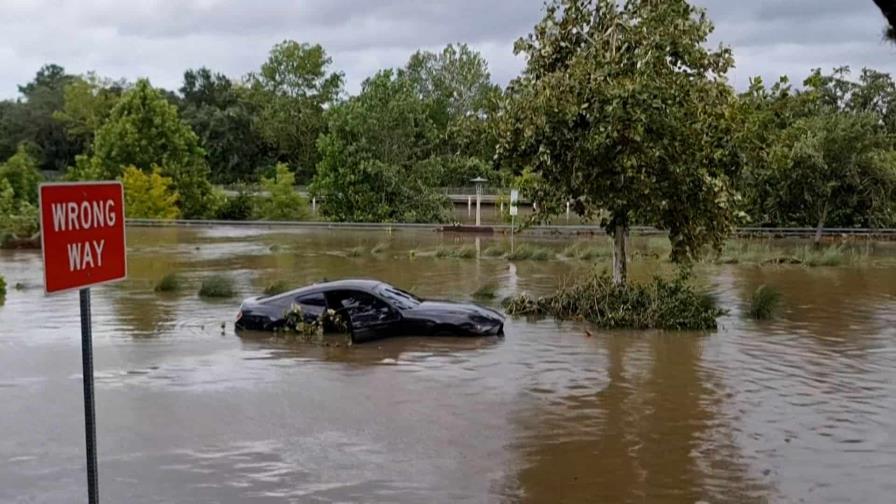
[{"x1": 311, "y1": 70, "x2": 449, "y2": 222}]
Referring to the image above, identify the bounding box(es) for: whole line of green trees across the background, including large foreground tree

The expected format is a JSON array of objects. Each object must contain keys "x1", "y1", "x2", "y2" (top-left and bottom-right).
[{"x1": 0, "y1": 0, "x2": 896, "y2": 280}]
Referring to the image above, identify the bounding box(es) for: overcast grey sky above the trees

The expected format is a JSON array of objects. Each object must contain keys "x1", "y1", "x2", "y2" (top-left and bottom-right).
[{"x1": 0, "y1": 0, "x2": 896, "y2": 98}]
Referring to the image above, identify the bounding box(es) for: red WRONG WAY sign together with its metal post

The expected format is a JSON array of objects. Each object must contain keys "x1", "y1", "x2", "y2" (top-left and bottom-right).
[{"x1": 39, "y1": 182, "x2": 127, "y2": 504}]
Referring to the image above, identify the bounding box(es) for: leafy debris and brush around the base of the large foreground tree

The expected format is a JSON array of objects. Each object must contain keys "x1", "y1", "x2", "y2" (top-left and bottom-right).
[{"x1": 505, "y1": 273, "x2": 723, "y2": 330}]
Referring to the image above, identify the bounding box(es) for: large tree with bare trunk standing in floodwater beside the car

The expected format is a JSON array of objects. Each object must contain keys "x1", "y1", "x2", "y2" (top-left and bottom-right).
[{"x1": 498, "y1": 0, "x2": 738, "y2": 283}]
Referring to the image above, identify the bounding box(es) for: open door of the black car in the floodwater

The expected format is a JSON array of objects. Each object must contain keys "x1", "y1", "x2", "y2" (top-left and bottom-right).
[{"x1": 327, "y1": 290, "x2": 401, "y2": 343}]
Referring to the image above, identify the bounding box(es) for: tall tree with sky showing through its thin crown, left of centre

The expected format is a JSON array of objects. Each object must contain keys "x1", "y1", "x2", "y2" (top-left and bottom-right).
[{"x1": 248, "y1": 40, "x2": 343, "y2": 180}]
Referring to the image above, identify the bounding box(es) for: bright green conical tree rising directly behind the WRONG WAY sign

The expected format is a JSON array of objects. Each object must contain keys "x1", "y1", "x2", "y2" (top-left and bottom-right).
[{"x1": 82, "y1": 79, "x2": 216, "y2": 219}]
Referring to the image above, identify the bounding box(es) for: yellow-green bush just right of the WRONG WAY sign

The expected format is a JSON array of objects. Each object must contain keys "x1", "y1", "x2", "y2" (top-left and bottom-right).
[{"x1": 121, "y1": 166, "x2": 180, "y2": 220}]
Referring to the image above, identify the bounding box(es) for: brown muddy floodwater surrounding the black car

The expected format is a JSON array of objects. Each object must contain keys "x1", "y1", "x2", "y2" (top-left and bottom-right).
[{"x1": 0, "y1": 227, "x2": 896, "y2": 503}]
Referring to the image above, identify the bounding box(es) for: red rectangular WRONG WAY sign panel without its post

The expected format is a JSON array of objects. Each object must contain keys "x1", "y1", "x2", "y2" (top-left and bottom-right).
[{"x1": 40, "y1": 182, "x2": 127, "y2": 294}]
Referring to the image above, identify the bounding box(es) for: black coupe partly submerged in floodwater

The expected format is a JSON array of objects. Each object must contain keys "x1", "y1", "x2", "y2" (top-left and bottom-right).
[{"x1": 236, "y1": 280, "x2": 504, "y2": 343}]
